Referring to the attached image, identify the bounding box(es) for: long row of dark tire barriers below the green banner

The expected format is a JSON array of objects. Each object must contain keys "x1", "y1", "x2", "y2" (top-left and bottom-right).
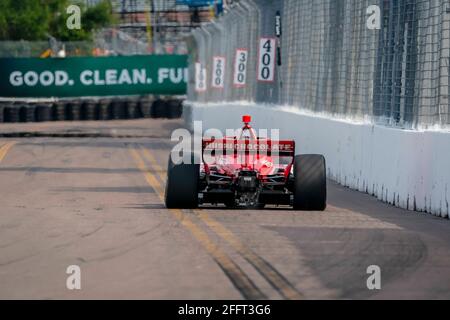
[{"x1": 0, "y1": 96, "x2": 183, "y2": 123}]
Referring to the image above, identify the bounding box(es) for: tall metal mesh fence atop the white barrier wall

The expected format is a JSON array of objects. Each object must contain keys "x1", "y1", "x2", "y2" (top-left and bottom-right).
[{"x1": 189, "y1": 0, "x2": 450, "y2": 128}]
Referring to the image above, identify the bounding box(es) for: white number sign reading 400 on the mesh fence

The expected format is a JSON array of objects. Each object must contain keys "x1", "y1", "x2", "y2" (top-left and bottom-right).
[{"x1": 258, "y1": 38, "x2": 276, "y2": 82}]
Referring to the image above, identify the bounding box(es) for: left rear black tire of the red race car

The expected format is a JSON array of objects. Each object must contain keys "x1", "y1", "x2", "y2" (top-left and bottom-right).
[{"x1": 165, "y1": 153, "x2": 200, "y2": 209}]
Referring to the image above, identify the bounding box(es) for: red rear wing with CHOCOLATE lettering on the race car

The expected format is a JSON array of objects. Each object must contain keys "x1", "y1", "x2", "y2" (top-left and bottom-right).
[{"x1": 202, "y1": 138, "x2": 295, "y2": 157}]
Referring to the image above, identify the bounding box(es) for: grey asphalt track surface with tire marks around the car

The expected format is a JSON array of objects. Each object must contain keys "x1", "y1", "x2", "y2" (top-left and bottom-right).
[{"x1": 0, "y1": 120, "x2": 450, "y2": 299}]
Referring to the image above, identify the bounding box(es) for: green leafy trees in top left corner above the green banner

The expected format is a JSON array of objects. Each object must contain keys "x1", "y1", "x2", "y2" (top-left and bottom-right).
[{"x1": 0, "y1": 0, "x2": 114, "y2": 41}]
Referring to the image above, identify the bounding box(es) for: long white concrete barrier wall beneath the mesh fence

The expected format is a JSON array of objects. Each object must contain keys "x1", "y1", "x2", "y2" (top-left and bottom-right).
[{"x1": 185, "y1": 103, "x2": 450, "y2": 217}]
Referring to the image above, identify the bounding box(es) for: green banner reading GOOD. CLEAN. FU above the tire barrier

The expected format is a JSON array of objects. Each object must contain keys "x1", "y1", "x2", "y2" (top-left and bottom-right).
[{"x1": 0, "y1": 55, "x2": 188, "y2": 97}]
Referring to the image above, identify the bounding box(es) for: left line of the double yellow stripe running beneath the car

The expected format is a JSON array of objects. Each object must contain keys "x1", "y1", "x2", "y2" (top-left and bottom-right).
[{"x1": 129, "y1": 148, "x2": 266, "y2": 299}]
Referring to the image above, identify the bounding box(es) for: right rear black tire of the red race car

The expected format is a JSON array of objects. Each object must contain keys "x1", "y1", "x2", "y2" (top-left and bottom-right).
[{"x1": 293, "y1": 154, "x2": 327, "y2": 211}]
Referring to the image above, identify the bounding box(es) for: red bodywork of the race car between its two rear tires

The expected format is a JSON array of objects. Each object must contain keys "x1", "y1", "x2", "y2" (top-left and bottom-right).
[{"x1": 200, "y1": 116, "x2": 295, "y2": 206}]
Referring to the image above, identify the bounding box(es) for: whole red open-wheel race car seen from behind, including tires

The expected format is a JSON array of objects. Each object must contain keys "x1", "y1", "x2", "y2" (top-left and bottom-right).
[{"x1": 165, "y1": 116, "x2": 327, "y2": 211}]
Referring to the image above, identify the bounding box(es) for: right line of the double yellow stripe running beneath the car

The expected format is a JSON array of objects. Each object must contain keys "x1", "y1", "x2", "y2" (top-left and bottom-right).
[{"x1": 141, "y1": 148, "x2": 304, "y2": 300}]
